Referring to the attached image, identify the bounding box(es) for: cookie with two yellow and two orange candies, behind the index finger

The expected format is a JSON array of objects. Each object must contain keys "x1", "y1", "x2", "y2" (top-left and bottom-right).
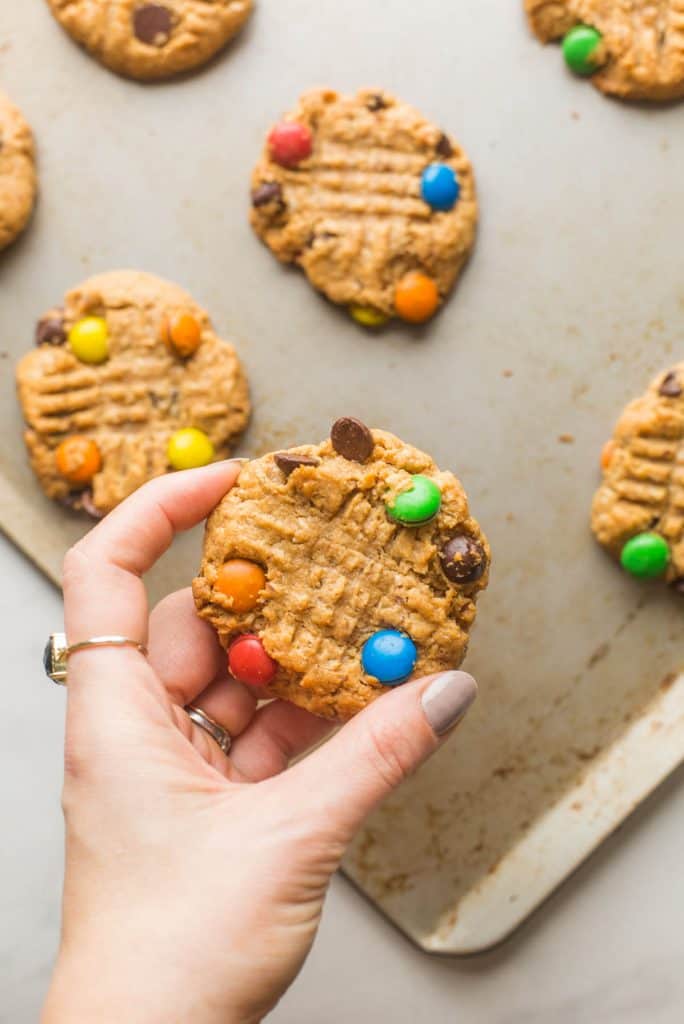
[{"x1": 16, "y1": 270, "x2": 250, "y2": 516}]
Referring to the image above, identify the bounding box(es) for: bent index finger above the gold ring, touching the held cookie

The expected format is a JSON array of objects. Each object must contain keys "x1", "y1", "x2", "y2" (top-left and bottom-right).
[{"x1": 62, "y1": 461, "x2": 240, "y2": 644}]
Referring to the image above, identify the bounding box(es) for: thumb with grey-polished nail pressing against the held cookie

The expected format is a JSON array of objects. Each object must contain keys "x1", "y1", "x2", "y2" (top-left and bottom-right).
[{"x1": 288, "y1": 672, "x2": 477, "y2": 842}]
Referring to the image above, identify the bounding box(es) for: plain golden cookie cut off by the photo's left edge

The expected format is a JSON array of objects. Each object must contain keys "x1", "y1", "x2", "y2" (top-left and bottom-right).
[{"x1": 0, "y1": 92, "x2": 37, "y2": 249}]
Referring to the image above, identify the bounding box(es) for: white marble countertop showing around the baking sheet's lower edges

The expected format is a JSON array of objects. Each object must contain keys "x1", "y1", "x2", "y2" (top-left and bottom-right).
[{"x1": 0, "y1": 537, "x2": 684, "y2": 1024}]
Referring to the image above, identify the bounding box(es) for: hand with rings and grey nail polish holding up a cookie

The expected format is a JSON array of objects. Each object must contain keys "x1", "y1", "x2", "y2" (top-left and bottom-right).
[{"x1": 43, "y1": 462, "x2": 476, "y2": 1024}]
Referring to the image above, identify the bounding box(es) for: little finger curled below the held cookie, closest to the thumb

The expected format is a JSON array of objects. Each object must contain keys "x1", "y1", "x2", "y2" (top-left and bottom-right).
[{"x1": 229, "y1": 700, "x2": 333, "y2": 782}]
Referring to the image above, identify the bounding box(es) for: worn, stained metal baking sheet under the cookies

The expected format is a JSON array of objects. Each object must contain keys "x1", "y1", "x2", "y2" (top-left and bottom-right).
[{"x1": 0, "y1": 0, "x2": 684, "y2": 952}]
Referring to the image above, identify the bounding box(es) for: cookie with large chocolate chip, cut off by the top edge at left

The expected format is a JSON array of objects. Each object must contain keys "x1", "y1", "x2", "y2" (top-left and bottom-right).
[{"x1": 48, "y1": 0, "x2": 252, "y2": 81}]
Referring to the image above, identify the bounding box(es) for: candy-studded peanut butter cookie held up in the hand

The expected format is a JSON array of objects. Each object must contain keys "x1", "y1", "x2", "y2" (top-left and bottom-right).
[{"x1": 193, "y1": 417, "x2": 489, "y2": 721}]
